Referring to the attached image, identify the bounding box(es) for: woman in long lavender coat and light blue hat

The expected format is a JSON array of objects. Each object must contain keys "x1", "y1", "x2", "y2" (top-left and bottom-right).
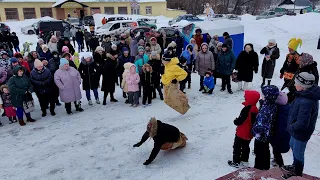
[{"x1": 54, "y1": 58, "x2": 83, "y2": 114}]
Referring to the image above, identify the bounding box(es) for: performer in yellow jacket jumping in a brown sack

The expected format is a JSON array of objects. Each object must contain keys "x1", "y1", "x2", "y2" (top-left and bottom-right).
[{"x1": 161, "y1": 47, "x2": 190, "y2": 114}]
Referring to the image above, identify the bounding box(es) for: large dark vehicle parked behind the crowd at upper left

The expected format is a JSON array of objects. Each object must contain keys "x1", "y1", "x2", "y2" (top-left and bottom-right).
[{"x1": 36, "y1": 20, "x2": 71, "y2": 35}]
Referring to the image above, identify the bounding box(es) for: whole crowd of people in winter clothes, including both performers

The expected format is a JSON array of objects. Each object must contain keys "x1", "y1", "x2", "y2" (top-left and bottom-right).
[{"x1": 0, "y1": 23, "x2": 320, "y2": 178}]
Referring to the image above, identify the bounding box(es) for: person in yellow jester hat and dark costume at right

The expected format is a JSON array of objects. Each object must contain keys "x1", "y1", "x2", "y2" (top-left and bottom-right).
[{"x1": 280, "y1": 38, "x2": 302, "y2": 102}]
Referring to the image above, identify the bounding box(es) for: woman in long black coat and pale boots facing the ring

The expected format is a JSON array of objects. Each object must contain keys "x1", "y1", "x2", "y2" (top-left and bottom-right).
[{"x1": 235, "y1": 44, "x2": 259, "y2": 90}]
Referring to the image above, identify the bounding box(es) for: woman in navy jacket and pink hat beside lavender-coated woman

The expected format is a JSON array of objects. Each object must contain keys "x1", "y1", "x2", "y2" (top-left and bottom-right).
[{"x1": 30, "y1": 59, "x2": 56, "y2": 117}]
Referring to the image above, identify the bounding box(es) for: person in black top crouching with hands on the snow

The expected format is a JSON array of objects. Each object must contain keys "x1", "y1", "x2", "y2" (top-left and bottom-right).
[{"x1": 133, "y1": 117, "x2": 188, "y2": 165}]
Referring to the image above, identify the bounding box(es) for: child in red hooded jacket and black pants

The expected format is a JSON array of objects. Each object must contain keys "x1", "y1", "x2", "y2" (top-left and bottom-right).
[{"x1": 228, "y1": 90, "x2": 260, "y2": 168}]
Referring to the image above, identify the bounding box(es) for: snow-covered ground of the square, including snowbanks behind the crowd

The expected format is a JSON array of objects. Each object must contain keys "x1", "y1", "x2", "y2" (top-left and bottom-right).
[{"x1": 0, "y1": 14, "x2": 320, "y2": 180}]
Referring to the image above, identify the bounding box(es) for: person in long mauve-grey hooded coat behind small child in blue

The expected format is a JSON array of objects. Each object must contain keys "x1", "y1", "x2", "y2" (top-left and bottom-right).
[{"x1": 196, "y1": 43, "x2": 215, "y2": 91}]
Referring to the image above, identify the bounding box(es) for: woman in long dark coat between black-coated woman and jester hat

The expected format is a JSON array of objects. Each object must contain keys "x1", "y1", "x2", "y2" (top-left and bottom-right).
[{"x1": 260, "y1": 39, "x2": 280, "y2": 87}]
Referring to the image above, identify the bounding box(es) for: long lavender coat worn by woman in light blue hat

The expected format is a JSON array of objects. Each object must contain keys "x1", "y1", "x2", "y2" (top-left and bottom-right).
[{"x1": 54, "y1": 67, "x2": 82, "y2": 103}]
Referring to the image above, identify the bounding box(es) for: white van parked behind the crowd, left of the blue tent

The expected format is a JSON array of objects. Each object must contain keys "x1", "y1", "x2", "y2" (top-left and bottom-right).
[{"x1": 96, "y1": 20, "x2": 139, "y2": 36}]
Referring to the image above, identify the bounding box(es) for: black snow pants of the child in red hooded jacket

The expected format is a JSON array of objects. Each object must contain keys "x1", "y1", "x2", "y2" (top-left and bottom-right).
[{"x1": 233, "y1": 135, "x2": 251, "y2": 164}]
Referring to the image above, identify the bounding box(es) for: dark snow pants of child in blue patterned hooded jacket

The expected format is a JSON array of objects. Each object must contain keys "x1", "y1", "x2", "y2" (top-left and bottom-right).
[{"x1": 254, "y1": 139, "x2": 270, "y2": 170}]
